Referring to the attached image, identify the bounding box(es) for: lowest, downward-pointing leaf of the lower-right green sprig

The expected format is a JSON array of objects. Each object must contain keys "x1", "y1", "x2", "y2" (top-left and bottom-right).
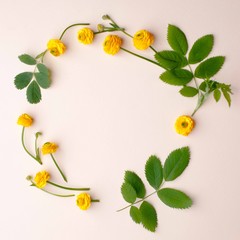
[{"x1": 139, "y1": 201, "x2": 158, "y2": 232}]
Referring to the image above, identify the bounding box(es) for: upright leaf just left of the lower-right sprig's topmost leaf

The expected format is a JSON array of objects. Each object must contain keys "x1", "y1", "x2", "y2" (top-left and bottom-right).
[{"x1": 145, "y1": 156, "x2": 163, "y2": 190}]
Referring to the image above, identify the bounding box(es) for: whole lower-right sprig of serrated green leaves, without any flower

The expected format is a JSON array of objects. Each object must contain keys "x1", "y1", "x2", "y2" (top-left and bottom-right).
[{"x1": 118, "y1": 147, "x2": 192, "y2": 232}]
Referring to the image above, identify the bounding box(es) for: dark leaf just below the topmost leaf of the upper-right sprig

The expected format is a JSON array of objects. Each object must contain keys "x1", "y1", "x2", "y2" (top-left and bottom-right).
[{"x1": 155, "y1": 50, "x2": 187, "y2": 69}]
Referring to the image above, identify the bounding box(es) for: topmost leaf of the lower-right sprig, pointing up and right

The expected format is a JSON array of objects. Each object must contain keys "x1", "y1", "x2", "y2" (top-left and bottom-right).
[{"x1": 163, "y1": 147, "x2": 190, "y2": 181}]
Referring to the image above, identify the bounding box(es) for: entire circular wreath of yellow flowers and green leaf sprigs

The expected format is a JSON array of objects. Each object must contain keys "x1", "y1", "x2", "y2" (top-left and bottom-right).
[{"x1": 14, "y1": 15, "x2": 232, "y2": 231}]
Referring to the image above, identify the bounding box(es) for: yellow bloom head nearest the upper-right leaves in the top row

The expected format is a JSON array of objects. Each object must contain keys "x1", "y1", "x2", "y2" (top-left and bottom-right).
[{"x1": 133, "y1": 30, "x2": 154, "y2": 50}]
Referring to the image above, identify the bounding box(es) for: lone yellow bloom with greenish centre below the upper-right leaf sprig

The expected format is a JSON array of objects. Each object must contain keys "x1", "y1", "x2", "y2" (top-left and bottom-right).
[{"x1": 175, "y1": 115, "x2": 195, "y2": 136}]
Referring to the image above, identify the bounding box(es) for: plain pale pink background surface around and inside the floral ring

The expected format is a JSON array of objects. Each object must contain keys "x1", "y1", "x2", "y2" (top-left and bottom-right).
[{"x1": 0, "y1": 0, "x2": 240, "y2": 240}]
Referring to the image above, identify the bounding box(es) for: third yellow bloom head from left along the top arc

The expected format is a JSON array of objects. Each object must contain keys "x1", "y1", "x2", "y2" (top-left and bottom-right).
[{"x1": 103, "y1": 35, "x2": 122, "y2": 55}]
